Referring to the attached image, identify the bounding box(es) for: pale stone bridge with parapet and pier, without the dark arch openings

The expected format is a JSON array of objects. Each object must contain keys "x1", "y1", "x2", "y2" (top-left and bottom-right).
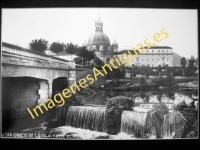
[{"x1": 2, "y1": 42, "x2": 75, "y2": 99}]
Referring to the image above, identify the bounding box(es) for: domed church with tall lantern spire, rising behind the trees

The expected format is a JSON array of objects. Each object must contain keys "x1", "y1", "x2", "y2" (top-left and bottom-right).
[{"x1": 87, "y1": 17, "x2": 118, "y2": 63}]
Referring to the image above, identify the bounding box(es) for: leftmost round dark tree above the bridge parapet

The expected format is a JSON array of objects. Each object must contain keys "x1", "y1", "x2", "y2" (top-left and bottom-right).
[{"x1": 29, "y1": 39, "x2": 48, "y2": 53}]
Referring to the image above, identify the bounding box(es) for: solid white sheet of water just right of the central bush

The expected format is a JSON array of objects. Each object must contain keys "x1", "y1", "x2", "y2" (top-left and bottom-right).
[{"x1": 121, "y1": 111, "x2": 147, "y2": 138}]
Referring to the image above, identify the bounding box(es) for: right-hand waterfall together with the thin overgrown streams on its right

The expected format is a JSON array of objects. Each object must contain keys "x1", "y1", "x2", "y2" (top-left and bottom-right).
[{"x1": 121, "y1": 111, "x2": 175, "y2": 138}]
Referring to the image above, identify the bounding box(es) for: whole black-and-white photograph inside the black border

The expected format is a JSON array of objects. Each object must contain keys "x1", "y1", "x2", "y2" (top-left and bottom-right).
[{"x1": 0, "y1": 7, "x2": 199, "y2": 140}]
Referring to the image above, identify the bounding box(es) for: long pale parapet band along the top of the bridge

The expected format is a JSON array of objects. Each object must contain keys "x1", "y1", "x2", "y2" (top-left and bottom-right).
[{"x1": 2, "y1": 42, "x2": 75, "y2": 69}]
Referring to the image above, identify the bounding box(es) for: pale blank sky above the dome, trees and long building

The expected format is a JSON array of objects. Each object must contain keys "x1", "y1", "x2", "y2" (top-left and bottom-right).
[{"x1": 1, "y1": 8, "x2": 198, "y2": 58}]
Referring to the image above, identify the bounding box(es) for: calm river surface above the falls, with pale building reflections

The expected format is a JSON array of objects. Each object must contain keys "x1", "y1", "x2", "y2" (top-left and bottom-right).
[{"x1": 86, "y1": 90, "x2": 198, "y2": 105}]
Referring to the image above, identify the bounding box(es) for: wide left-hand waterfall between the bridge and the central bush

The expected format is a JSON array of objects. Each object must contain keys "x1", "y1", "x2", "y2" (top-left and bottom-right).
[{"x1": 65, "y1": 106, "x2": 107, "y2": 132}]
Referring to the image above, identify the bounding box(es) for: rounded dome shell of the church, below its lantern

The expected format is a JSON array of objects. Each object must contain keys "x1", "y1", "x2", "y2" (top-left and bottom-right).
[{"x1": 88, "y1": 32, "x2": 110, "y2": 45}]
